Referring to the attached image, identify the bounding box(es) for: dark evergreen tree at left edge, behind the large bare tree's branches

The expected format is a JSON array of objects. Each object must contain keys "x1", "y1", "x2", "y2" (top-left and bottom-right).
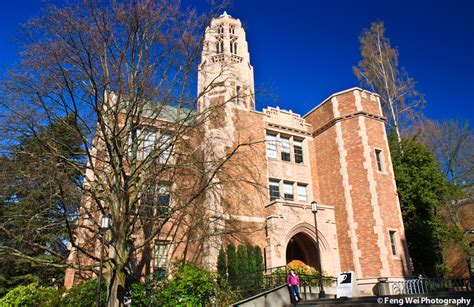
[{"x1": 0, "y1": 116, "x2": 82, "y2": 295}]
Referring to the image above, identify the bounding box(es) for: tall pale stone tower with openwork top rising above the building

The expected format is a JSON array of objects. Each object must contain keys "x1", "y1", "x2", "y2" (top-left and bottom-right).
[{"x1": 198, "y1": 12, "x2": 264, "y2": 268}]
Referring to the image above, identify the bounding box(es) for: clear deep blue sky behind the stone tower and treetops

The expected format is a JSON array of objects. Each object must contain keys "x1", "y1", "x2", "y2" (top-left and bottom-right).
[{"x1": 0, "y1": 0, "x2": 474, "y2": 122}]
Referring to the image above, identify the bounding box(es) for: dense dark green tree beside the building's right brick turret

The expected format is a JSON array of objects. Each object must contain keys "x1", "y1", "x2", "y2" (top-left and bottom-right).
[{"x1": 390, "y1": 137, "x2": 448, "y2": 276}]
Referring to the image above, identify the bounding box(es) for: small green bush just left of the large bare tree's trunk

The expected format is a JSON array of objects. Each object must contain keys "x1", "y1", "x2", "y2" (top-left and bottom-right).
[{"x1": 61, "y1": 279, "x2": 107, "y2": 307}]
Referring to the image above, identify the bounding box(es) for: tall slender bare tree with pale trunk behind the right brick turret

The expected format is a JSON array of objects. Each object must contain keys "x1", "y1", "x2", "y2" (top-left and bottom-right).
[{"x1": 353, "y1": 22, "x2": 424, "y2": 144}]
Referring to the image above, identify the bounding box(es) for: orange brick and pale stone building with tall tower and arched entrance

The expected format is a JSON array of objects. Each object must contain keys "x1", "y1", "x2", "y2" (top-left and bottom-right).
[{"x1": 66, "y1": 13, "x2": 411, "y2": 293}]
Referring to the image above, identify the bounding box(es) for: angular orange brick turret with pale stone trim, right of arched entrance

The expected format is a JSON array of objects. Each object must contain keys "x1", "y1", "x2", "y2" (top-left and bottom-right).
[{"x1": 305, "y1": 89, "x2": 409, "y2": 278}]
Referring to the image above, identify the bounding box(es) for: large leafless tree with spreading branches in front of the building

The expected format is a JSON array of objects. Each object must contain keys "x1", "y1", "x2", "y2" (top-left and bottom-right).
[{"x1": 0, "y1": 0, "x2": 264, "y2": 306}]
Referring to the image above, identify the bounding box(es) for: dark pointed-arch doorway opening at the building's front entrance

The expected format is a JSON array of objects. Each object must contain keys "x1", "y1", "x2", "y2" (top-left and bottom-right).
[{"x1": 286, "y1": 232, "x2": 319, "y2": 270}]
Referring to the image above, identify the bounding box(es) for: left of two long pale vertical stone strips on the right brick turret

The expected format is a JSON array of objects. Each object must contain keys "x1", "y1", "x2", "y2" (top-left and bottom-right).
[{"x1": 331, "y1": 97, "x2": 362, "y2": 277}]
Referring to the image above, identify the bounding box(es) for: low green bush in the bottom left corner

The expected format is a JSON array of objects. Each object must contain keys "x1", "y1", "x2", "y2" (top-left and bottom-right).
[{"x1": 0, "y1": 283, "x2": 60, "y2": 306}]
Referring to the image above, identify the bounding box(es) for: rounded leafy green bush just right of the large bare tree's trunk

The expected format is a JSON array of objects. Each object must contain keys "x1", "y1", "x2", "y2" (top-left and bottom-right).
[{"x1": 156, "y1": 263, "x2": 217, "y2": 306}]
